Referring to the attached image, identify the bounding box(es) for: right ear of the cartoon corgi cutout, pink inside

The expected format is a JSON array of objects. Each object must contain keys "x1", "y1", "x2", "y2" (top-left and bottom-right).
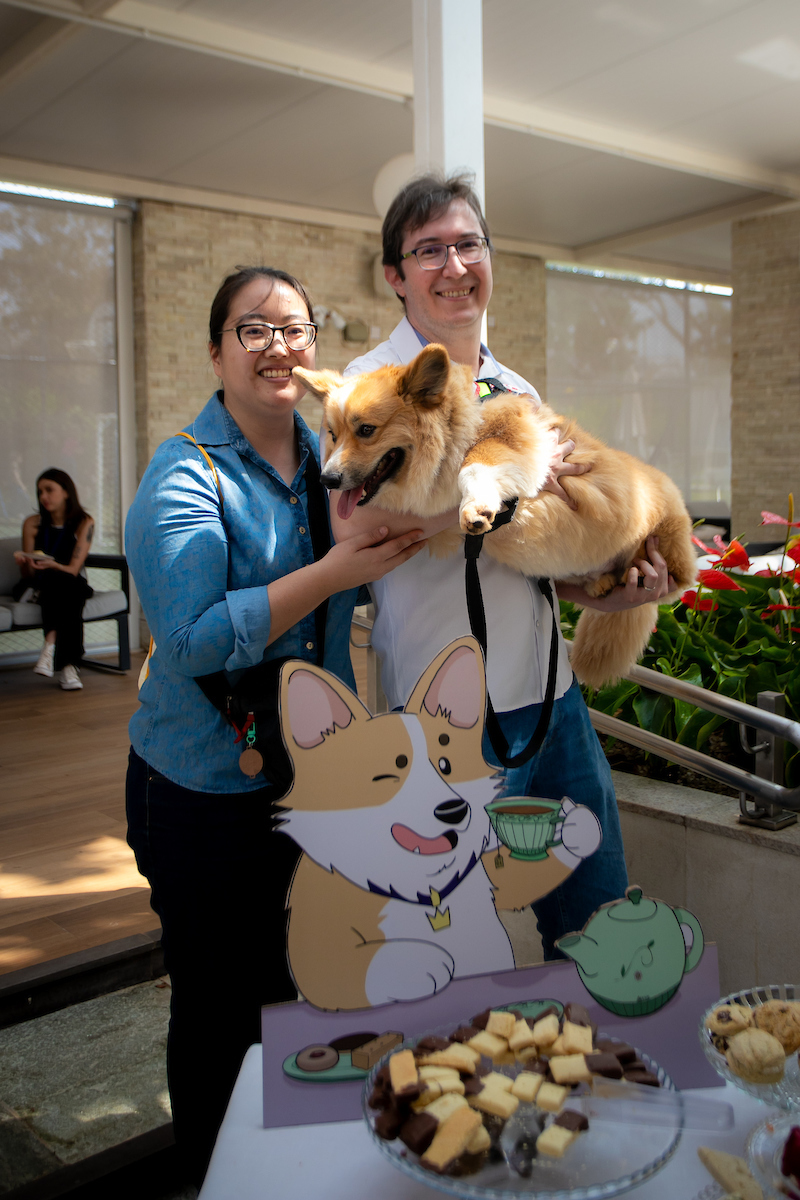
[{"x1": 404, "y1": 637, "x2": 486, "y2": 730}]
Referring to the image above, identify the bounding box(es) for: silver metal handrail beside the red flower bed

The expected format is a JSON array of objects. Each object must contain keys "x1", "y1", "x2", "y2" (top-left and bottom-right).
[{"x1": 589, "y1": 666, "x2": 800, "y2": 811}]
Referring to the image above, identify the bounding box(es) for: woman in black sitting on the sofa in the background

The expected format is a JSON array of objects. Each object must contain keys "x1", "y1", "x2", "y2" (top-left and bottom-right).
[{"x1": 14, "y1": 467, "x2": 95, "y2": 691}]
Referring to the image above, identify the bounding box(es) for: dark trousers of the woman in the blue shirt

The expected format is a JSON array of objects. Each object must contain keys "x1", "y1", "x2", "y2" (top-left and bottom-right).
[{"x1": 126, "y1": 750, "x2": 300, "y2": 1183}]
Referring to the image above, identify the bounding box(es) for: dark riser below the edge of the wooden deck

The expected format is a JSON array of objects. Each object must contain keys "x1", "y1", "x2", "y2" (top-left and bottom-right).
[{"x1": 0, "y1": 929, "x2": 164, "y2": 1028}]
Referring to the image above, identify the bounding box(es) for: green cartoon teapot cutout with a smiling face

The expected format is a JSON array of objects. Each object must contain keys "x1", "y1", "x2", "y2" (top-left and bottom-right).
[{"x1": 555, "y1": 887, "x2": 703, "y2": 1016}]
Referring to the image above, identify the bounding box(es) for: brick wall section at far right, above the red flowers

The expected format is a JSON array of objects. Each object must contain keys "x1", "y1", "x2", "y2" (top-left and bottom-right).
[{"x1": 730, "y1": 211, "x2": 800, "y2": 541}]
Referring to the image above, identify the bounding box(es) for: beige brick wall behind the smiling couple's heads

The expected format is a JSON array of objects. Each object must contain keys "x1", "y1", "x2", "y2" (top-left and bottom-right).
[{"x1": 133, "y1": 200, "x2": 545, "y2": 475}]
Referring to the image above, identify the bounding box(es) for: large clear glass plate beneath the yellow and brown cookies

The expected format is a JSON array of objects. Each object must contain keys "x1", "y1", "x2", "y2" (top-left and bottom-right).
[{"x1": 362, "y1": 1022, "x2": 682, "y2": 1200}]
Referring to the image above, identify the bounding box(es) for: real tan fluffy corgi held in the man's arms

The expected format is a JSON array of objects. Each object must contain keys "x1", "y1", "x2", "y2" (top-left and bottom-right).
[{"x1": 294, "y1": 344, "x2": 696, "y2": 688}]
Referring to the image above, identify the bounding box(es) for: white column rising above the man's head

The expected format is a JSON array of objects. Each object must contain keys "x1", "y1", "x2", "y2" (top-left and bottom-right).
[{"x1": 413, "y1": 0, "x2": 483, "y2": 205}]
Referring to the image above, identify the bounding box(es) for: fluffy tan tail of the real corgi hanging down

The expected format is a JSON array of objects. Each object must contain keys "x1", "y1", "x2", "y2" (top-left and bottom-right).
[{"x1": 570, "y1": 604, "x2": 658, "y2": 688}]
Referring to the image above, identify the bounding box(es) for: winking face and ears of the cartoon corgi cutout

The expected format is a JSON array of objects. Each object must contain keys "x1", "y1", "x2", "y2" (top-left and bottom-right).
[{"x1": 281, "y1": 637, "x2": 498, "y2": 902}]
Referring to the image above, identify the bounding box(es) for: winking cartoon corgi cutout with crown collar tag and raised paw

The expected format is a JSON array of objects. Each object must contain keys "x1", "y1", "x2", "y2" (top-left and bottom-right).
[{"x1": 279, "y1": 637, "x2": 601, "y2": 1009}]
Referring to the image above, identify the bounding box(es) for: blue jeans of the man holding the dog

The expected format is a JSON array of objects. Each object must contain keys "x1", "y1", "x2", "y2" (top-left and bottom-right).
[{"x1": 483, "y1": 680, "x2": 627, "y2": 959}]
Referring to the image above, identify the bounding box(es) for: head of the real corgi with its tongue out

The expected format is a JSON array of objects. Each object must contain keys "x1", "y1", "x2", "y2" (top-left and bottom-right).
[{"x1": 294, "y1": 346, "x2": 473, "y2": 520}]
